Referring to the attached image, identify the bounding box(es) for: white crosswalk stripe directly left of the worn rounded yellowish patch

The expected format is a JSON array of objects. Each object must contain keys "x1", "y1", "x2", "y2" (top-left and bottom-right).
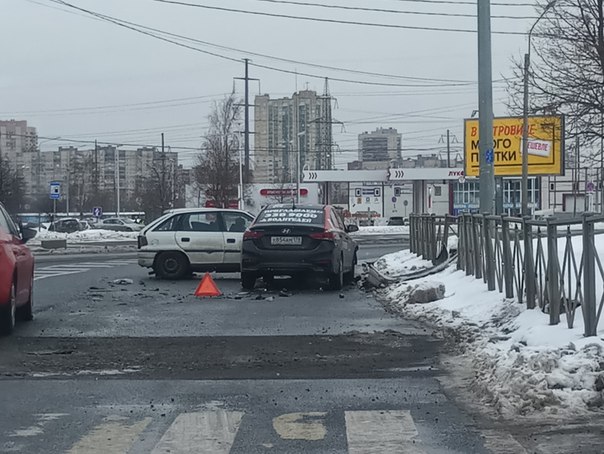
[{"x1": 151, "y1": 410, "x2": 243, "y2": 454}]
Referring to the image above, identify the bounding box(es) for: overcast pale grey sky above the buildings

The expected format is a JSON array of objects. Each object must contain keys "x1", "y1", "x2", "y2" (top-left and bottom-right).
[{"x1": 0, "y1": 0, "x2": 536, "y2": 167}]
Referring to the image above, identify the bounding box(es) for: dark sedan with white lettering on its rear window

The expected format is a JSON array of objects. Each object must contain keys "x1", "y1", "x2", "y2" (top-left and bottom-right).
[{"x1": 241, "y1": 204, "x2": 358, "y2": 290}]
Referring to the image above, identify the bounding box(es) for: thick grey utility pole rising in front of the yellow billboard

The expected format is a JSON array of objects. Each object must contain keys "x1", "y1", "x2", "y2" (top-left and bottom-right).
[{"x1": 477, "y1": 0, "x2": 495, "y2": 214}]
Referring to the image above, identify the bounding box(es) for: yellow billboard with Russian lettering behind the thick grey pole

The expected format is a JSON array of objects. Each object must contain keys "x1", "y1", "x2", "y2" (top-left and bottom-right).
[{"x1": 464, "y1": 116, "x2": 564, "y2": 177}]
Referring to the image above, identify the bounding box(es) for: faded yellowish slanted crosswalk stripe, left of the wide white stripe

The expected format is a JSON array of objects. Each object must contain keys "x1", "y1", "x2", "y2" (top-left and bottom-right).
[{"x1": 67, "y1": 416, "x2": 151, "y2": 454}]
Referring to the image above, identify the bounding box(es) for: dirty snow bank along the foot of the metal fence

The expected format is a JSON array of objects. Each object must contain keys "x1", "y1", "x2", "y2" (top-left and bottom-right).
[{"x1": 380, "y1": 264, "x2": 604, "y2": 416}]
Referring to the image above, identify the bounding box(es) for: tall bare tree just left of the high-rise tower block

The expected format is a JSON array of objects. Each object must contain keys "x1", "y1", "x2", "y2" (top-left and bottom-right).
[{"x1": 194, "y1": 94, "x2": 241, "y2": 208}]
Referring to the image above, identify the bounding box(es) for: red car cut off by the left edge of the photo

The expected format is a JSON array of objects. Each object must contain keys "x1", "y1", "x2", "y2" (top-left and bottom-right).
[{"x1": 0, "y1": 203, "x2": 36, "y2": 335}]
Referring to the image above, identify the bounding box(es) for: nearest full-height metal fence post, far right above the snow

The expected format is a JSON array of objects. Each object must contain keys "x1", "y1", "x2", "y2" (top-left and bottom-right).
[{"x1": 582, "y1": 216, "x2": 598, "y2": 336}]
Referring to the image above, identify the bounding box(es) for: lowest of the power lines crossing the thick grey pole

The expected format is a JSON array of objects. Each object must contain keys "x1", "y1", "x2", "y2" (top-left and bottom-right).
[{"x1": 152, "y1": 0, "x2": 526, "y2": 35}]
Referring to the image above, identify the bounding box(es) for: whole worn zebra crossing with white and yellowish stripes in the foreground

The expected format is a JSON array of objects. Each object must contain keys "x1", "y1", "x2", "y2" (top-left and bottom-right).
[{"x1": 8, "y1": 406, "x2": 527, "y2": 454}]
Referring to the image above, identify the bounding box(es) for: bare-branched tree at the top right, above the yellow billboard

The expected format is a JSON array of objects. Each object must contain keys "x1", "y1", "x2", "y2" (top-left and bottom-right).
[{"x1": 507, "y1": 0, "x2": 604, "y2": 155}]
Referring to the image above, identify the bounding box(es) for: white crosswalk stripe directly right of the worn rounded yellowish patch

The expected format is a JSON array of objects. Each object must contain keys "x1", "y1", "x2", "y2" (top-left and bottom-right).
[{"x1": 345, "y1": 410, "x2": 425, "y2": 454}]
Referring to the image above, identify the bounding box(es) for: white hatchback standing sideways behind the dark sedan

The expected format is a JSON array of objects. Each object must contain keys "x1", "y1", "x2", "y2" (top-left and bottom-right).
[{"x1": 138, "y1": 208, "x2": 254, "y2": 279}]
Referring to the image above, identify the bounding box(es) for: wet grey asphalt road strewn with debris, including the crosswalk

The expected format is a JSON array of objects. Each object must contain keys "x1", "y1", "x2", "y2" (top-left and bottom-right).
[{"x1": 0, "y1": 244, "x2": 601, "y2": 454}]
